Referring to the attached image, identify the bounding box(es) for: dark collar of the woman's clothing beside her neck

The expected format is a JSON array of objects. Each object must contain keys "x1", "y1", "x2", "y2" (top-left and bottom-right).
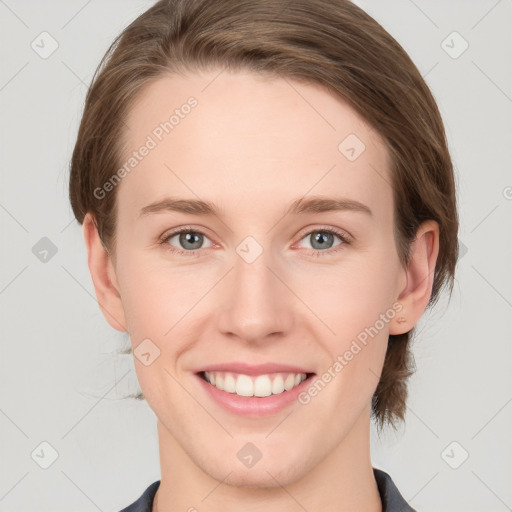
[{"x1": 121, "y1": 468, "x2": 416, "y2": 512}]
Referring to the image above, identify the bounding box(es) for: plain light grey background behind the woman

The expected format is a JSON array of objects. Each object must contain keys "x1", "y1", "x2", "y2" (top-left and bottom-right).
[{"x1": 0, "y1": 0, "x2": 512, "y2": 512}]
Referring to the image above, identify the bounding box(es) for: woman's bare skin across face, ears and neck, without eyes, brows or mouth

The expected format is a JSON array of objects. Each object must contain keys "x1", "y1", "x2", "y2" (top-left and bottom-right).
[{"x1": 83, "y1": 70, "x2": 439, "y2": 512}]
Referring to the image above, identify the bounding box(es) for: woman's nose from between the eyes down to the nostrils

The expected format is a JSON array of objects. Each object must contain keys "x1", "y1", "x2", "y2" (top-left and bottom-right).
[{"x1": 219, "y1": 236, "x2": 292, "y2": 341}]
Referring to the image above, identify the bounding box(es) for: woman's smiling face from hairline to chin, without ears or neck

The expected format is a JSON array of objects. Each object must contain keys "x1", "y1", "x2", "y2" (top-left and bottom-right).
[{"x1": 103, "y1": 71, "x2": 405, "y2": 486}]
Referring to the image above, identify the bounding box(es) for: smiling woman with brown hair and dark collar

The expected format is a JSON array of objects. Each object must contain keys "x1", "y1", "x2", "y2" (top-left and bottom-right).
[{"x1": 70, "y1": 0, "x2": 458, "y2": 512}]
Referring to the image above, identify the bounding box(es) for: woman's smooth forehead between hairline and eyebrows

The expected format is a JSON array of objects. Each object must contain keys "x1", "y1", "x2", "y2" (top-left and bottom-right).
[{"x1": 117, "y1": 70, "x2": 392, "y2": 222}]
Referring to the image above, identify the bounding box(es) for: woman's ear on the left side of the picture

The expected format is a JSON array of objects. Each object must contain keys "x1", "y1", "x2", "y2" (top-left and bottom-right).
[{"x1": 83, "y1": 213, "x2": 127, "y2": 332}]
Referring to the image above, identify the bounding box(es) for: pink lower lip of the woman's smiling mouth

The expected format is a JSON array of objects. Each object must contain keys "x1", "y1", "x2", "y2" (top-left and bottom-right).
[{"x1": 195, "y1": 373, "x2": 314, "y2": 418}]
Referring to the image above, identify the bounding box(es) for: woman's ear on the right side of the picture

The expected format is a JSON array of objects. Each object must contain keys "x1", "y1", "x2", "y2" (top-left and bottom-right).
[{"x1": 389, "y1": 220, "x2": 439, "y2": 334}]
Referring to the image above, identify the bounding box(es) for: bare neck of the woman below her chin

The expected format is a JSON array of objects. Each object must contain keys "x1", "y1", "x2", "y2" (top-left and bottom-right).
[{"x1": 152, "y1": 409, "x2": 382, "y2": 512}]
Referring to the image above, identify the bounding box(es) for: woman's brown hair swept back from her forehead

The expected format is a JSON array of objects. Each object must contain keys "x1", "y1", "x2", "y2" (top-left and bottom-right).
[{"x1": 69, "y1": 0, "x2": 458, "y2": 429}]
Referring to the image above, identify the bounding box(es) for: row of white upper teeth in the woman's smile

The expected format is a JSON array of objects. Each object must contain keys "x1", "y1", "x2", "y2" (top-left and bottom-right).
[{"x1": 204, "y1": 372, "x2": 307, "y2": 397}]
